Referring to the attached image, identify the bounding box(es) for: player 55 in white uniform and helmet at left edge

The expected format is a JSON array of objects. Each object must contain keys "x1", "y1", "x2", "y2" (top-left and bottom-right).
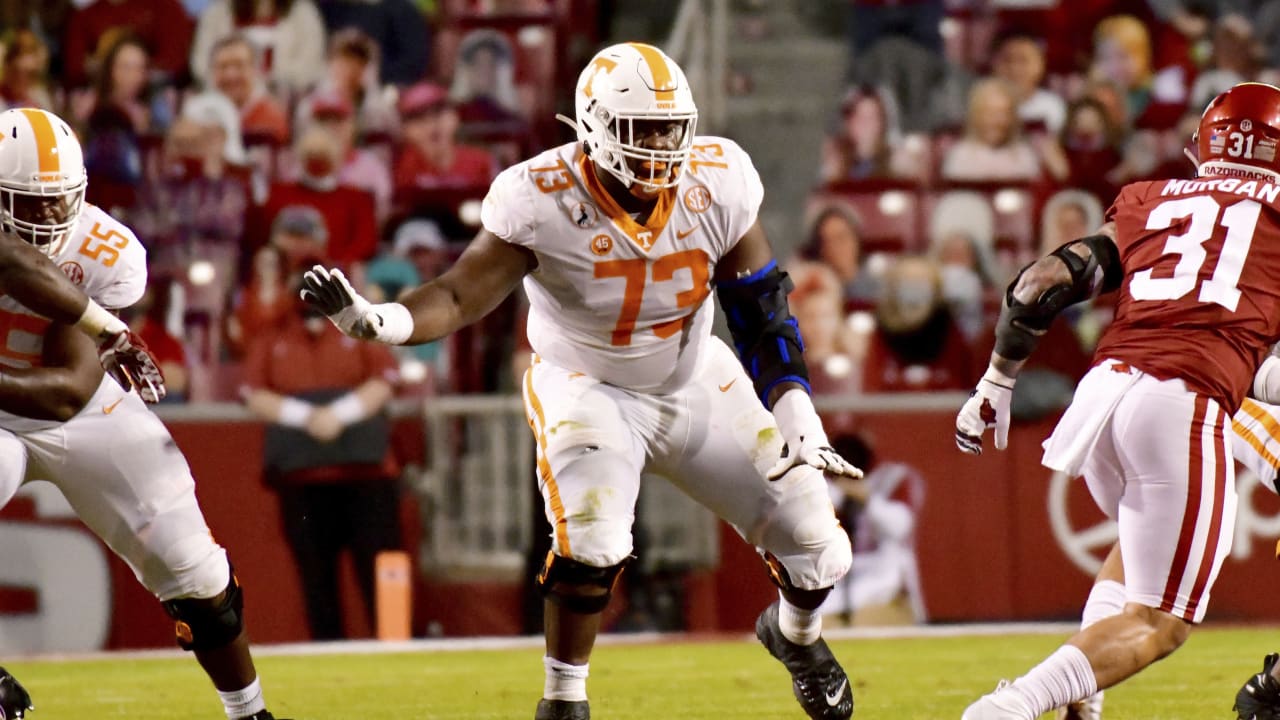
[{"x1": 0, "y1": 109, "x2": 288, "y2": 720}]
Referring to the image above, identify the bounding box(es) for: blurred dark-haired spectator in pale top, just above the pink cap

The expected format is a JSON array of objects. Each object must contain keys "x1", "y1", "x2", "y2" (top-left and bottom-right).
[{"x1": 294, "y1": 28, "x2": 397, "y2": 136}]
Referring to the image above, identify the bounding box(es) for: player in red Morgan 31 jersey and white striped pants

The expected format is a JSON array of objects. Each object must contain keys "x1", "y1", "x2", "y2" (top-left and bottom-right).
[{"x1": 956, "y1": 83, "x2": 1280, "y2": 720}]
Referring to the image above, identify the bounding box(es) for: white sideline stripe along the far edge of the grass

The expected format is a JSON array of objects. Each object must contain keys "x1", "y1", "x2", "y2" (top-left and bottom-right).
[{"x1": 20, "y1": 623, "x2": 1080, "y2": 662}]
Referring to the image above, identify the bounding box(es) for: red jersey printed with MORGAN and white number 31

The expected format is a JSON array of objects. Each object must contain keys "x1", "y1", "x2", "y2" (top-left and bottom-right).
[{"x1": 1094, "y1": 177, "x2": 1280, "y2": 411}]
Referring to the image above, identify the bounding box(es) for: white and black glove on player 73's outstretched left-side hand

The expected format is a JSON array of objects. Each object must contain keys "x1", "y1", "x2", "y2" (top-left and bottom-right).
[{"x1": 302, "y1": 265, "x2": 413, "y2": 345}]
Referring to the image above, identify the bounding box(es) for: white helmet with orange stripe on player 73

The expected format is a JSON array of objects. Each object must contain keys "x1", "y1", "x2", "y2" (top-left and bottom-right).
[{"x1": 561, "y1": 42, "x2": 698, "y2": 190}]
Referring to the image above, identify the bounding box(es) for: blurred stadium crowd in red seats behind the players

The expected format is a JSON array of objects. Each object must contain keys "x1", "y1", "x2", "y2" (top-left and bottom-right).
[{"x1": 0, "y1": 0, "x2": 1259, "y2": 414}]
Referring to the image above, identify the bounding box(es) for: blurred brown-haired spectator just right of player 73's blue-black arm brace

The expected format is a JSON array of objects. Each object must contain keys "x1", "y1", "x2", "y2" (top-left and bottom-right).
[{"x1": 797, "y1": 200, "x2": 879, "y2": 307}]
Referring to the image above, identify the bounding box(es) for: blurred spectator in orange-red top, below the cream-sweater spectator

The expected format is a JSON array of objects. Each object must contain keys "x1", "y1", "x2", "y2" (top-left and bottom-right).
[{"x1": 209, "y1": 32, "x2": 289, "y2": 143}]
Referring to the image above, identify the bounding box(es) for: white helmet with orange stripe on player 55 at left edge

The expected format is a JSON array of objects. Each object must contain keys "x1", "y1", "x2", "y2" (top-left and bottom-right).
[{"x1": 0, "y1": 108, "x2": 88, "y2": 256}]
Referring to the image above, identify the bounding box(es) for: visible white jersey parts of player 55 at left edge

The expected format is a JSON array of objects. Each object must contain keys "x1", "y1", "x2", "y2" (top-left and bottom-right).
[{"x1": 0, "y1": 205, "x2": 147, "y2": 432}]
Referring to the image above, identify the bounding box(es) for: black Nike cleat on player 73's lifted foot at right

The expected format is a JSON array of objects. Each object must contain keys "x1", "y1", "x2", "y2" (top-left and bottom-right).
[{"x1": 755, "y1": 602, "x2": 854, "y2": 720}]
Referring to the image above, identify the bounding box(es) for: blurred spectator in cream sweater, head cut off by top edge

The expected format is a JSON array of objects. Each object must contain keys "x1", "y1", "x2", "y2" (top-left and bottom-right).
[{"x1": 192, "y1": 0, "x2": 325, "y2": 95}]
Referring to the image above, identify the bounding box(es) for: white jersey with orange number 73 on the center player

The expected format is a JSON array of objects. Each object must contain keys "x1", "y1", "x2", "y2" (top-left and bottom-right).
[{"x1": 481, "y1": 136, "x2": 764, "y2": 393}]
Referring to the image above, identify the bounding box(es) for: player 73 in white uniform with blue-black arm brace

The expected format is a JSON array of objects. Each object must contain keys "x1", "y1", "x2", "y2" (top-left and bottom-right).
[{"x1": 303, "y1": 44, "x2": 861, "y2": 720}]
